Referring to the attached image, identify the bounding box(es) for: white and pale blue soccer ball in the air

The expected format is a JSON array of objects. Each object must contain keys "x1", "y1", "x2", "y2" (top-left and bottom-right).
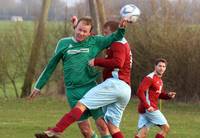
[{"x1": 120, "y1": 4, "x2": 141, "y2": 23}]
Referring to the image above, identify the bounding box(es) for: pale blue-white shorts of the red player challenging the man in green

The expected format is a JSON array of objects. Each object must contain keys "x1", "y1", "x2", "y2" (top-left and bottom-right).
[{"x1": 80, "y1": 78, "x2": 131, "y2": 127}]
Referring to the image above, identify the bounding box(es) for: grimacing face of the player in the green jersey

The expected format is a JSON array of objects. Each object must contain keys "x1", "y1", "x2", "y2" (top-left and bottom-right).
[{"x1": 75, "y1": 21, "x2": 91, "y2": 42}]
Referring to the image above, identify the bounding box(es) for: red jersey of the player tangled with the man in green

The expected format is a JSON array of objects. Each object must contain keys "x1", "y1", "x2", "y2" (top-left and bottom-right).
[{"x1": 94, "y1": 38, "x2": 132, "y2": 85}]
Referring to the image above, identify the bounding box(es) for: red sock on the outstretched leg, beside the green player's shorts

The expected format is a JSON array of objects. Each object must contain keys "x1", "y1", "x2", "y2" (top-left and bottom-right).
[{"x1": 51, "y1": 108, "x2": 83, "y2": 132}]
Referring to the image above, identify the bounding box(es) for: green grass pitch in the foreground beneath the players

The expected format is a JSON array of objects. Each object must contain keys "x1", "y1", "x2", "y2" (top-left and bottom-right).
[{"x1": 0, "y1": 97, "x2": 200, "y2": 138}]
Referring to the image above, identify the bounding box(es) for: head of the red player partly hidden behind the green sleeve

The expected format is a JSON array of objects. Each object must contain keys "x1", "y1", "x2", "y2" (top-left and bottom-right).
[{"x1": 103, "y1": 21, "x2": 119, "y2": 35}]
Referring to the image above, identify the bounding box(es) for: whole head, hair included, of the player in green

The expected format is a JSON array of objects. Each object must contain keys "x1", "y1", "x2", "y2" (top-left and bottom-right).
[{"x1": 75, "y1": 16, "x2": 93, "y2": 42}]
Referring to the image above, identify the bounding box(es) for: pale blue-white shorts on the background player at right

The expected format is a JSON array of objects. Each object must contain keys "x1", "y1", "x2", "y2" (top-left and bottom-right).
[{"x1": 138, "y1": 110, "x2": 168, "y2": 129}]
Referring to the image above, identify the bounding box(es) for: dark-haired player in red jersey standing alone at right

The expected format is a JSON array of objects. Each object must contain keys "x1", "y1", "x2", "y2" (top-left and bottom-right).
[{"x1": 135, "y1": 58, "x2": 176, "y2": 138}]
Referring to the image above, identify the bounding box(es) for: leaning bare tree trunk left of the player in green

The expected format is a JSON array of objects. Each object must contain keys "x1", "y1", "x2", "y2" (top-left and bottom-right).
[{"x1": 21, "y1": 0, "x2": 51, "y2": 97}]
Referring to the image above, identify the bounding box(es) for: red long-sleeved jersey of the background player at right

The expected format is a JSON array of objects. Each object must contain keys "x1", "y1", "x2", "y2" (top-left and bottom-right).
[{"x1": 137, "y1": 72, "x2": 170, "y2": 113}]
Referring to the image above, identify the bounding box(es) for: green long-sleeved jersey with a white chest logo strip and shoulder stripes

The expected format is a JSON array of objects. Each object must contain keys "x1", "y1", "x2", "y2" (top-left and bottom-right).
[{"x1": 35, "y1": 28, "x2": 125, "y2": 90}]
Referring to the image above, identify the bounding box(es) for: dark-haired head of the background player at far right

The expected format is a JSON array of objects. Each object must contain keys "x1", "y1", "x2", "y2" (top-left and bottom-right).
[{"x1": 155, "y1": 58, "x2": 167, "y2": 76}]
